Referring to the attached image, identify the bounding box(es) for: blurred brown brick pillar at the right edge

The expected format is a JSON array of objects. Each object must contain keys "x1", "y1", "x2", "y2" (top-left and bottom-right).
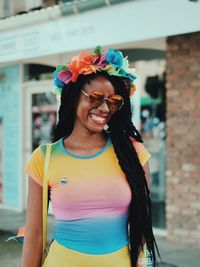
[{"x1": 166, "y1": 32, "x2": 200, "y2": 244}]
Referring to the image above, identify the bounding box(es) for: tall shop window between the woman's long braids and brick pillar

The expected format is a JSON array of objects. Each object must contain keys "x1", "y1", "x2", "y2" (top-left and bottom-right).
[{"x1": 136, "y1": 59, "x2": 166, "y2": 229}]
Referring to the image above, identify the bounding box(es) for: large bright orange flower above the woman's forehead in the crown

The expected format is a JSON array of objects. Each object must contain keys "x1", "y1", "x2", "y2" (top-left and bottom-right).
[{"x1": 69, "y1": 51, "x2": 96, "y2": 82}]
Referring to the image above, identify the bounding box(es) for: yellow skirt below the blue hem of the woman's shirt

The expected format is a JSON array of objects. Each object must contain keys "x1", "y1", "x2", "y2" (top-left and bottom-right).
[{"x1": 43, "y1": 240, "x2": 131, "y2": 267}]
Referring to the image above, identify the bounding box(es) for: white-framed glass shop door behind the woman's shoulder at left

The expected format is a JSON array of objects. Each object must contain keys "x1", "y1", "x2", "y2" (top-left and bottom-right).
[{"x1": 23, "y1": 81, "x2": 58, "y2": 213}]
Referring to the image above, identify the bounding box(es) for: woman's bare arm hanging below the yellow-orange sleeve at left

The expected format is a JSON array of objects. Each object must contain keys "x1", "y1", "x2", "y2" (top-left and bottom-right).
[{"x1": 22, "y1": 177, "x2": 43, "y2": 267}]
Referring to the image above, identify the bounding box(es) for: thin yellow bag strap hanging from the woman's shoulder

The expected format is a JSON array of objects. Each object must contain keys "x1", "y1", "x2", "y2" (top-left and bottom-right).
[{"x1": 42, "y1": 144, "x2": 51, "y2": 257}]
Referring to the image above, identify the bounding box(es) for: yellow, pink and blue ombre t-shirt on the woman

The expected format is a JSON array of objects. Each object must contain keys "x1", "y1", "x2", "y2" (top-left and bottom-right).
[{"x1": 26, "y1": 139, "x2": 150, "y2": 266}]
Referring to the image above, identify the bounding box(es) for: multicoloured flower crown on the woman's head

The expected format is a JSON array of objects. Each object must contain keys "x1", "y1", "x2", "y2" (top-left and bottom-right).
[{"x1": 53, "y1": 46, "x2": 137, "y2": 95}]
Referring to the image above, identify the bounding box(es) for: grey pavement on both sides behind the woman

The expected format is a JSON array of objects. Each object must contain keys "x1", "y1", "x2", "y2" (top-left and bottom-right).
[{"x1": 0, "y1": 210, "x2": 200, "y2": 267}]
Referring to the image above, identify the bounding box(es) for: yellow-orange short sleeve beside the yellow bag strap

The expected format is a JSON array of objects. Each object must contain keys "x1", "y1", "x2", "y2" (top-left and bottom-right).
[{"x1": 25, "y1": 147, "x2": 44, "y2": 186}]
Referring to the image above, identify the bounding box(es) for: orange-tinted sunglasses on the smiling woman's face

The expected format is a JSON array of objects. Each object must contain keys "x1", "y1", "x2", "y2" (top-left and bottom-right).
[{"x1": 81, "y1": 90, "x2": 124, "y2": 112}]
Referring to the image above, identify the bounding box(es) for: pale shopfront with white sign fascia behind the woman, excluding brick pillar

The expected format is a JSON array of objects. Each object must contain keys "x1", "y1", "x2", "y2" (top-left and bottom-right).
[{"x1": 0, "y1": 0, "x2": 199, "y2": 243}]
